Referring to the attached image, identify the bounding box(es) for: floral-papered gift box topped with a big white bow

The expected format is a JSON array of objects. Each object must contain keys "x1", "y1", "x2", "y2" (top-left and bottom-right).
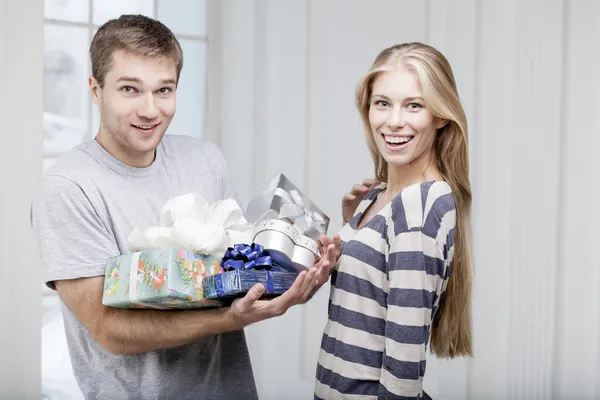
[{"x1": 102, "y1": 193, "x2": 252, "y2": 309}]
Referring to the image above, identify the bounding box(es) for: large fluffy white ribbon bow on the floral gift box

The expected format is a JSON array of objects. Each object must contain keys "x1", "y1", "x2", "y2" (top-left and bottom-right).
[{"x1": 128, "y1": 193, "x2": 252, "y2": 257}]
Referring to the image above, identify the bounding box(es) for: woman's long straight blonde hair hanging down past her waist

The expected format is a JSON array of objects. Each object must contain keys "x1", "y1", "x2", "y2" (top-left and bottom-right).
[{"x1": 356, "y1": 43, "x2": 473, "y2": 358}]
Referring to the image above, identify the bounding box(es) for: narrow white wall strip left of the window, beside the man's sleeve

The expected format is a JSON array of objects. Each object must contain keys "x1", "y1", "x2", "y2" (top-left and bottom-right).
[{"x1": 0, "y1": 0, "x2": 44, "y2": 399}]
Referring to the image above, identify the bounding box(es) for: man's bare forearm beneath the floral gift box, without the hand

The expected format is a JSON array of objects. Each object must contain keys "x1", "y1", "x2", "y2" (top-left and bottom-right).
[{"x1": 102, "y1": 308, "x2": 242, "y2": 354}]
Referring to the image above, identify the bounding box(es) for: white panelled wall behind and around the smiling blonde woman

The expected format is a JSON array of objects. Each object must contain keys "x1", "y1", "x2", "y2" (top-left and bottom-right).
[{"x1": 216, "y1": 0, "x2": 600, "y2": 399}]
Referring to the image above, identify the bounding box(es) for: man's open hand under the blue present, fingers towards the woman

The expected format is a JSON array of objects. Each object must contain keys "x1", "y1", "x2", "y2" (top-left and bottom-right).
[{"x1": 229, "y1": 235, "x2": 342, "y2": 329}]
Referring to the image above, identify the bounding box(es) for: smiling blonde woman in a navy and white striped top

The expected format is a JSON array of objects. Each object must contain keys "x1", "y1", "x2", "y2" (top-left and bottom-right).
[{"x1": 315, "y1": 43, "x2": 472, "y2": 399}]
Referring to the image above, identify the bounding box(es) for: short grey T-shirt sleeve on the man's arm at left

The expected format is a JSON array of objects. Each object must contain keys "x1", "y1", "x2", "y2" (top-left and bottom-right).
[{"x1": 31, "y1": 175, "x2": 119, "y2": 289}]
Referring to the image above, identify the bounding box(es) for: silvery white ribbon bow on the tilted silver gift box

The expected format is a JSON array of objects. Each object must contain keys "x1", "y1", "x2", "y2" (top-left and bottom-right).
[{"x1": 275, "y1": 187, "x2": 325, "y2": 234}]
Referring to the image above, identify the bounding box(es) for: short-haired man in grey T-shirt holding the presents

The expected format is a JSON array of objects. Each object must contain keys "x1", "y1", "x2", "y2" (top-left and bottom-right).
[{"x1": 32, "y1": 16, "x2": 339, "y2": 400}]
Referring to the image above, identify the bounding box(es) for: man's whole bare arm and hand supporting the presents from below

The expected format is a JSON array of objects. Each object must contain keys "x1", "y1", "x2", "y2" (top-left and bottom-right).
[{"x1": 55, "y1": 244, "x2": 337, "y2": 354}]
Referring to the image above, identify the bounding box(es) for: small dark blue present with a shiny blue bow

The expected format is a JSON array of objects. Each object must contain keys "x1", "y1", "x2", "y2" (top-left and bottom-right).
[{"x1": 203, "y1": 243, "x2": 298, "y2": 302}]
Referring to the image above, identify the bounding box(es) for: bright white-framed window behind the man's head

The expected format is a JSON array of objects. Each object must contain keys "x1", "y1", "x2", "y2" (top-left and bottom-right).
[{"x1": 44, "y1": 0, "x2": 207, "y2": 169}]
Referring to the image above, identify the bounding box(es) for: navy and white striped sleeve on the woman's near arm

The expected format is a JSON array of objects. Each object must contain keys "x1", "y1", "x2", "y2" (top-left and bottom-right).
[{"x1": 378, "y1": 192, "x2": 446, "y2": 399}]
